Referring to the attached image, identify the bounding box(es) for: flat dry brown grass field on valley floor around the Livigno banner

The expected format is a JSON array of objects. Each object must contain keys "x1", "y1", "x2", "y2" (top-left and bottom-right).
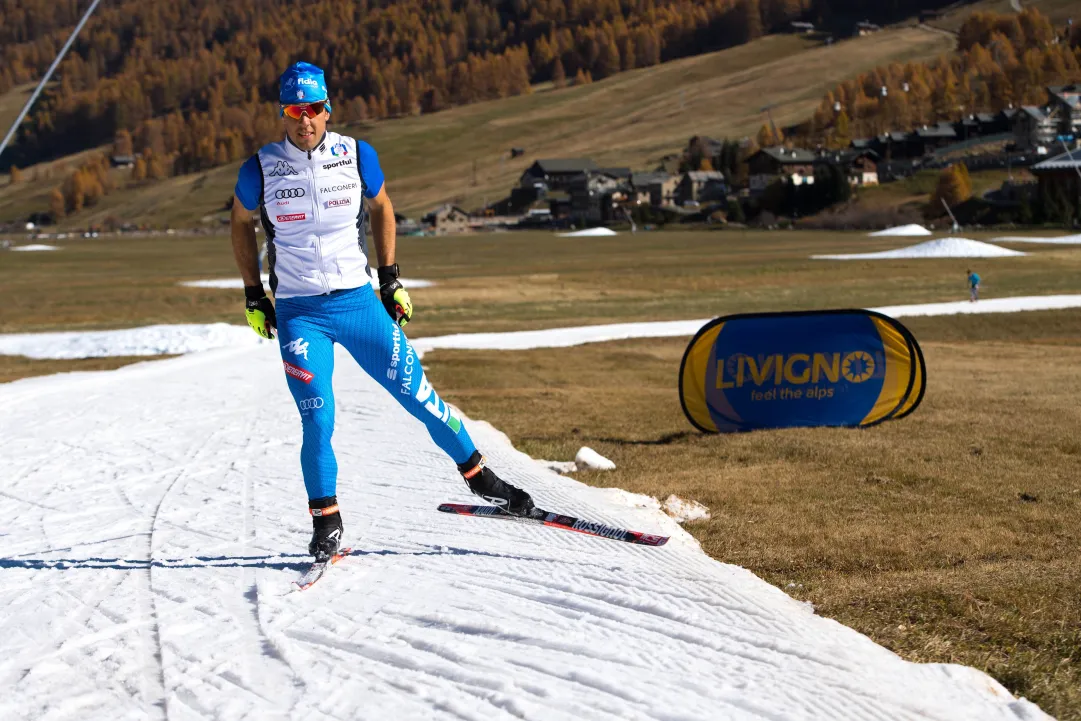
[{"x1": 0, "y1": 231, "x2": 1081, "y2": 721}]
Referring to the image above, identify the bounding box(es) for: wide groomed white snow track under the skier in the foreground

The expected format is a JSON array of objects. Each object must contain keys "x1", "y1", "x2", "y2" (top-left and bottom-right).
[{"x1": 0, "y1": 346, "x2": 1047, "y2": 721}]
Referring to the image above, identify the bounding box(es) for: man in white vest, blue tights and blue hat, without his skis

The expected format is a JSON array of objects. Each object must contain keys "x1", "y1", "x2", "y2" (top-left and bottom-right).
[{"x1": 231, "y1": 63, "x2": 541, "y2": 562}]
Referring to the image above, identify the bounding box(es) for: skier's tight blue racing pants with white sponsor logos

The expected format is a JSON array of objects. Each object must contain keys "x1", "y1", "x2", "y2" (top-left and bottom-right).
[{"x1": 277, "y1": 285, "x2": 476, "y2": 499}]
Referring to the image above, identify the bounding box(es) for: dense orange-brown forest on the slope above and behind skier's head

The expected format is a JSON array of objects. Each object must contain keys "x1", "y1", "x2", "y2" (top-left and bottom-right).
[{"x1": 0, "y1": 0, "x2": 964, "y2": 175}]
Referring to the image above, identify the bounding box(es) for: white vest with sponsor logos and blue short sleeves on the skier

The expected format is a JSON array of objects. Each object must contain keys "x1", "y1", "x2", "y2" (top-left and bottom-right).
[{"x1": 237, "y1": 131, "x2": 383, "y2": 298}]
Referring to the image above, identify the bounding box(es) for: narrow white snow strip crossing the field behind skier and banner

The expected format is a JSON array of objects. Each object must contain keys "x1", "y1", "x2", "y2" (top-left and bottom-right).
[{"x1": 6, "y1": 295, "x2": 1081, "y2": 359}]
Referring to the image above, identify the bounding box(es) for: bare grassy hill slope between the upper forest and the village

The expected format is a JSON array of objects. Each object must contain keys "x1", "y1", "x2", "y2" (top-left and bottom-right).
[{"x1": 0, "y1": 28, "x2": 952, "y2": 227}]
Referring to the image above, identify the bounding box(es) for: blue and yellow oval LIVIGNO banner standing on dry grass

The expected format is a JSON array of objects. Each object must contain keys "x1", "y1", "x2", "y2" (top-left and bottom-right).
[{"x1": 679, "y1": 310, "x2": 926, "y2": 432}]
